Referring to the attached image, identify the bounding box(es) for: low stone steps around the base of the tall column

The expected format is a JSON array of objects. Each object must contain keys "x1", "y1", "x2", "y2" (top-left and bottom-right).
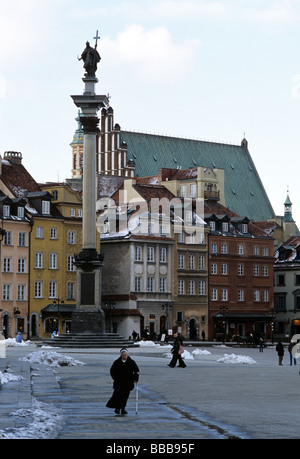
[{"x1": 37, "y1": 333, "x2": 136, "y2": 348}]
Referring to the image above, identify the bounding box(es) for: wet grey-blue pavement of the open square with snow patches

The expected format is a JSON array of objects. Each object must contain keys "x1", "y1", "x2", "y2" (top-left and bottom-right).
[{"x1": 0, "y1": 344, "x2": 300, "y2": 441}]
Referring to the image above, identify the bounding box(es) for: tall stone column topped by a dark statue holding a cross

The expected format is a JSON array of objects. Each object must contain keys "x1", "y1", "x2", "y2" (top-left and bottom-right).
[{"x1": 71, "y1": 32, "x2": 109, "y2": 334}]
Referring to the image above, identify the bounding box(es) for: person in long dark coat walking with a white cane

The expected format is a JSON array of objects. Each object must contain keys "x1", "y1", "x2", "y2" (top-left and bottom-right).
[{"x1": 106, "y1": 349, "x2": 140, "y2": 414}]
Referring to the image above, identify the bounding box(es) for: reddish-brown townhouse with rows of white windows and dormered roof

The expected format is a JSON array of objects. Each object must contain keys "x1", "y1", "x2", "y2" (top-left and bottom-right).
[{"x1": 205, "y1": 202, "x2": 274, "y2": 340}]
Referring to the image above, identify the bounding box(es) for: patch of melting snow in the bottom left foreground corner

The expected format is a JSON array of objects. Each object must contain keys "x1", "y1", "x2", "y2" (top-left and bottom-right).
[{"x1": 0, "y1": 398, "x2": 64, "y2": 440}]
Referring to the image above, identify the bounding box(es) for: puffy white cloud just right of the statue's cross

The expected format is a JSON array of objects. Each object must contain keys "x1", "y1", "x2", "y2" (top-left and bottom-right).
[{"x1": 101, "y1": 25, "x2": 200, "y2": 81}]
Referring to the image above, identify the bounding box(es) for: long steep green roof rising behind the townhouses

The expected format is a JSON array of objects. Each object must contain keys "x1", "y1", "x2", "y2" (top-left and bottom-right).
[{"x1": 121, "y1": 131, "x2": 275, "y2": 221}]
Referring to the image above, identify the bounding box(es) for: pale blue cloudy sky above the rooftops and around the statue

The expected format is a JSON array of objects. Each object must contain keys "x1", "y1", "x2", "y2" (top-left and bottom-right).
[{"x1": 0, "y1": 0, "x2": 300, "y2": 225}]
